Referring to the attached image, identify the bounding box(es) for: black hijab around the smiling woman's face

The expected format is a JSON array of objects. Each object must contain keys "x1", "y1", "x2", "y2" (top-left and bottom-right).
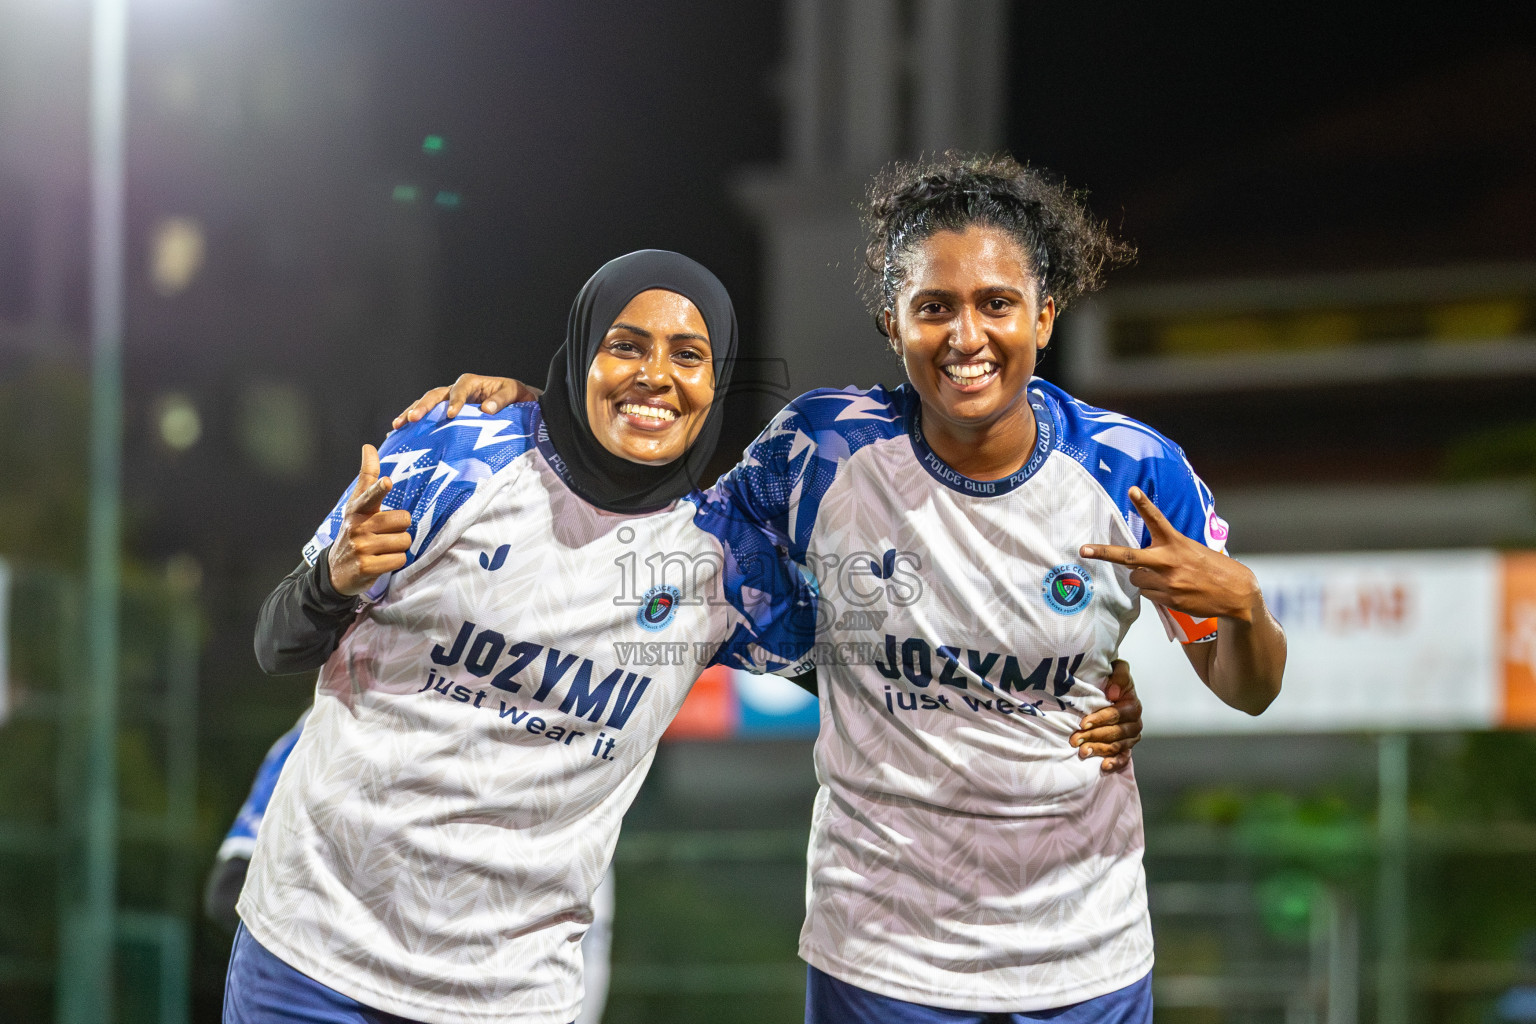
[{"x1": 539, "y1": 249, "x2": 736, "y2": 513}]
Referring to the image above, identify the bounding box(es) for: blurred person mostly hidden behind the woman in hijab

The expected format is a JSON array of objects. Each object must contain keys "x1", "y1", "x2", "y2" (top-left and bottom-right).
[{"x1": 203, "y1": 708, "x2": 616, "y2": 1024}]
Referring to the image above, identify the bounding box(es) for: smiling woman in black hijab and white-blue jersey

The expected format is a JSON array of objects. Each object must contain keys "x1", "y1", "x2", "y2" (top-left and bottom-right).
[{"x1": 233, "y1": 252, "x2": 814, "y2": 1024}]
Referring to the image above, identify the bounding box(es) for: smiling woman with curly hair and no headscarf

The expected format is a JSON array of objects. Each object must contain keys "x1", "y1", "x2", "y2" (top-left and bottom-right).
[{"x1": 396, "y1": 154, "x2": 1286, "y2": 1024}]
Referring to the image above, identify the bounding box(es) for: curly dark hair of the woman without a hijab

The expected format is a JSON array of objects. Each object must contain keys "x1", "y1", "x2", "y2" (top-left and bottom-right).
[{"x1": 859, "y1": 152, "x2": 1137, "y2": 333}]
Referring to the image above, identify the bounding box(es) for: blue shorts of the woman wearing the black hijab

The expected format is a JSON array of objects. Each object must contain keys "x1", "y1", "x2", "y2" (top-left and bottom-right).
[{"x1": 224, "y1": 924, "x2": 416, "y2": 1024}]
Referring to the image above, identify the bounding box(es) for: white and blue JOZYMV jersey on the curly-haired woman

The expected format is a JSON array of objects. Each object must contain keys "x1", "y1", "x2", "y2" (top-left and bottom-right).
[{"x1": 719, "y1": 379, "x2": 1226, "y2": 1013}]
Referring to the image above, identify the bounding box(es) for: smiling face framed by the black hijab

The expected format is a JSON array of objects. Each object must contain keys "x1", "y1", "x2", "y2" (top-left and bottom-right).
[{"x1": 587, "y1": 289, "x2": 714, "y2": 465}]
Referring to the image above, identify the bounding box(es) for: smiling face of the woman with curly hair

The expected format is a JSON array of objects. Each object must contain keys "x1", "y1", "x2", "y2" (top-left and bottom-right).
[{"x1": 885, "y1": 224, "x2": 1055, "y2": 461}]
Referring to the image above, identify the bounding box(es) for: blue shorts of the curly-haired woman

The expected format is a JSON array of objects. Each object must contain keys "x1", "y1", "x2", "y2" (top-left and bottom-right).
[{"x1": 805, "y1": 967, "x2": 1152, "y2": 1024}]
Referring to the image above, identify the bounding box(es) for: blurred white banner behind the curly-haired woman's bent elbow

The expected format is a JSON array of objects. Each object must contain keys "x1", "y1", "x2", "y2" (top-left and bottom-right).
[{"x1": 1120, "y1": 551, "x2": 1505, "y2": 735}]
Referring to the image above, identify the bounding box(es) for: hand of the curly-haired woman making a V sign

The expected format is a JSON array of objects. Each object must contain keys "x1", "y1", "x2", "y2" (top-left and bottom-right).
[{"x1": 1080, "y1": 487, "x2": 1263, "y2": 622}]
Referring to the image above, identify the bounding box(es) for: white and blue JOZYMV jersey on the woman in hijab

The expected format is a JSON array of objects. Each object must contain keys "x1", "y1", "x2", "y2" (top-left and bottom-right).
[{"x1": 240, "y1": 404, "x2": 814, "y2": 1024}]
